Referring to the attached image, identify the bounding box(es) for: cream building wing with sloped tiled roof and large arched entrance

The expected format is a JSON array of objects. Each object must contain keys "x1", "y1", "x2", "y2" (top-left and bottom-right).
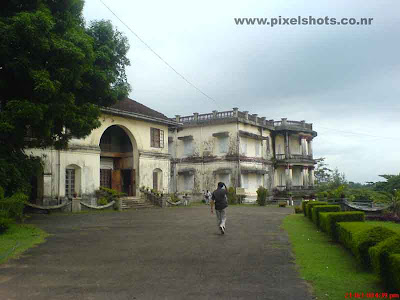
[{"x1": 26, "y1": 99, "x2": 177, "y2": 205}]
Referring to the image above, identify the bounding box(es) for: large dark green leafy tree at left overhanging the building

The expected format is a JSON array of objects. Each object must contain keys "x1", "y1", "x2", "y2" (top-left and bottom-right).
[{"x1": 0, "y1": 0, "x2": 130, "y2": 194}]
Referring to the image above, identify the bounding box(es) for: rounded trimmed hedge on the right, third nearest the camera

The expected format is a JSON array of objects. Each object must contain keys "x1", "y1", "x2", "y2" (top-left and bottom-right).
[{"x1": 352, "y1": 226, "x2": 396, "y2": 268}]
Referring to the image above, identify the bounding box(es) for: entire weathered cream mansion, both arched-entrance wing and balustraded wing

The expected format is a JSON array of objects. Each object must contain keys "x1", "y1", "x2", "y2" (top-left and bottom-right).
[{"x1": 27, "y1": 99, "x2": 317, "y2": 205}]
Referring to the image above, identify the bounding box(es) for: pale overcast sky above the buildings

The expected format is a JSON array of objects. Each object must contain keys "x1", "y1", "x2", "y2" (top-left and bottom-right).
[{"x1": 84, "y1": 0, "x2": 400, "y2": 182}]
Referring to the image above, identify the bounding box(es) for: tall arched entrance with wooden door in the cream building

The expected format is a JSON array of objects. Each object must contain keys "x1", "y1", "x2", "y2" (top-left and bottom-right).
[{"x1": 99, "y1": 125, "x2": 138, "y2": 196}]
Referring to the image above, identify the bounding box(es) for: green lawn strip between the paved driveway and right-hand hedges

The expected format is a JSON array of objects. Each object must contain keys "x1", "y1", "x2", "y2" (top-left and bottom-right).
[{"x1": 283, "y1": 215, "x2": 384, "y2": 300}]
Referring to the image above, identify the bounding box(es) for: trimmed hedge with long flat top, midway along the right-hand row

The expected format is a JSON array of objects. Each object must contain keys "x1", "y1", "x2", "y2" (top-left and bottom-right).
[{"x1": 319, "y1": 211, "x2": 365, "y2": 240}]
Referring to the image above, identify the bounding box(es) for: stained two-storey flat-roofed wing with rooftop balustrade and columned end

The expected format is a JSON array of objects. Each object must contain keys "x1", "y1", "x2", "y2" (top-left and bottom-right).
[{"x1": 168, "y1": 108, "x2": 317, "y2": 201}]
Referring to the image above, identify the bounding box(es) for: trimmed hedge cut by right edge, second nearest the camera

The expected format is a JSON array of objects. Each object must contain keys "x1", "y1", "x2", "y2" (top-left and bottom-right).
[{"x1": 368, "y1": 234, "x2": 400, "y2": 281}]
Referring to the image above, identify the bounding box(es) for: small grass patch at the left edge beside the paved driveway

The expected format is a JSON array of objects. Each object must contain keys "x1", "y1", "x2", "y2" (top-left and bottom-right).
[{"x1": 0, "y1": 224, "x2": 48, "y2": 264}]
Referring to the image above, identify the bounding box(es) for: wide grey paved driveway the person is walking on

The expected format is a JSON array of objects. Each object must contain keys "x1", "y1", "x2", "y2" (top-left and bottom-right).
[{"x1": 0, "y1": 206, "x2": 312, "y2": 300}]
